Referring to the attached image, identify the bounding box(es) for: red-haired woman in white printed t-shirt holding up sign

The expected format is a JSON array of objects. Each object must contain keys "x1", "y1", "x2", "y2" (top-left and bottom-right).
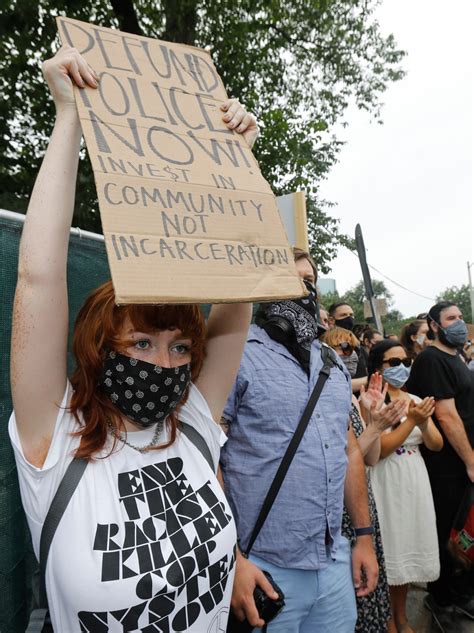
[{"x1": 10, "y1": 48, "x2": 266, "y2": 633}]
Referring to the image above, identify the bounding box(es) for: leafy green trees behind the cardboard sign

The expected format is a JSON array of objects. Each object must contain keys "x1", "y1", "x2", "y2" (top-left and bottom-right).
[{"x1": 0, "y1": 0, "x2": 404, "y2": 272}]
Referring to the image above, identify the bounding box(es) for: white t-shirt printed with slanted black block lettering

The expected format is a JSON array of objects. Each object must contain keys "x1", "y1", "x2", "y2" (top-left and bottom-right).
[{"x1": 9, "y1": 384, "x2": 236, "y2": 633}]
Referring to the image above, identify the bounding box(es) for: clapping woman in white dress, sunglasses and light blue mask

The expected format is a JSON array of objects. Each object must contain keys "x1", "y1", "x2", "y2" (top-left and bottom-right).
[{"x1": 368, "y1": 340, "x2": 443, "y2": 633}]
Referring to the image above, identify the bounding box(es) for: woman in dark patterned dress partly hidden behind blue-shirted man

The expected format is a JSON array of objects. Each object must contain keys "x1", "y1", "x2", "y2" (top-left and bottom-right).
[{"x1": 324, "y1": 327, "x2": 403, "y2": 633}]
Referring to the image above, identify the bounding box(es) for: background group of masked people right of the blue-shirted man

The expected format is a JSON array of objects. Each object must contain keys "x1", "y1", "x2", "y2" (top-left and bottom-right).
[{"x1": 314, "y1": 301, "x2": 474, "y2": 632}]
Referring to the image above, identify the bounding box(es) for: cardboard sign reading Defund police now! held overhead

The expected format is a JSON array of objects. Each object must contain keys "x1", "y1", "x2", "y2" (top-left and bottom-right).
[{"x1": 57, "y1": 18, "x2": 304, "y2": 303}]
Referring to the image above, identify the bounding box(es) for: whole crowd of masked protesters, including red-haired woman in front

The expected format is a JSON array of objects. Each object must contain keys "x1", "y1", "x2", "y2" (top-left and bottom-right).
[{"x1": 9, "y1": 48, "x2": 474, "y2": 633}]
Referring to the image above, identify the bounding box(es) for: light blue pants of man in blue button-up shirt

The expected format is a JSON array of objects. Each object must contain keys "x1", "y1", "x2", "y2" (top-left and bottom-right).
[{"x1": 249, "y1": 536, "x2": 357, "y2": 633}]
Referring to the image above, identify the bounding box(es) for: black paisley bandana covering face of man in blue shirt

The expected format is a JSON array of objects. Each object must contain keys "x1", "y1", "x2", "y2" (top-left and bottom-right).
[{"x1": 255, "y1": 281, "x2": 323, "y2": 373}]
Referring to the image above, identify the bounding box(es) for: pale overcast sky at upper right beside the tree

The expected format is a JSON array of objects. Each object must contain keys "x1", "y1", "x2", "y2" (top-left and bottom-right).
[{"x1": 321, "y1": 0, "x2": 474, "y2": 316}]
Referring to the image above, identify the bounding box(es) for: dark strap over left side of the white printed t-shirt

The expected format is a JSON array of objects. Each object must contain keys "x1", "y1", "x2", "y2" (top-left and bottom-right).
[{"x1": 25, "y1": 458, "x2": 88, "y2": 633}]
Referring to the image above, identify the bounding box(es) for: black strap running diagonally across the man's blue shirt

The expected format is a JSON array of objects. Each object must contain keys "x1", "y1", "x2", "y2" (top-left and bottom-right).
[{"x1": 242, "y1": 344, "x2": 336, "y2": 557}]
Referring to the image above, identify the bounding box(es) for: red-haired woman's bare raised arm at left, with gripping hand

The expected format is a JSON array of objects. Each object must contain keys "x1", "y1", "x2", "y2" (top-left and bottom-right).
[{"x1": 11, "y1": 48, "x2": 97, "y2": 466}]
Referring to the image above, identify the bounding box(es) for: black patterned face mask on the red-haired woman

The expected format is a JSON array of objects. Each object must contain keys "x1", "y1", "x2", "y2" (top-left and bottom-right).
[{"x1": 99, "y1": 351, "x2": 191, "y2": 428}]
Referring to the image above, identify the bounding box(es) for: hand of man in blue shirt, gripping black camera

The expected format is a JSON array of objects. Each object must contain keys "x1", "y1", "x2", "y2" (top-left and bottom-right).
[{"x1": 231, "y1": 550, "x2": 278, "y2": 627}]
